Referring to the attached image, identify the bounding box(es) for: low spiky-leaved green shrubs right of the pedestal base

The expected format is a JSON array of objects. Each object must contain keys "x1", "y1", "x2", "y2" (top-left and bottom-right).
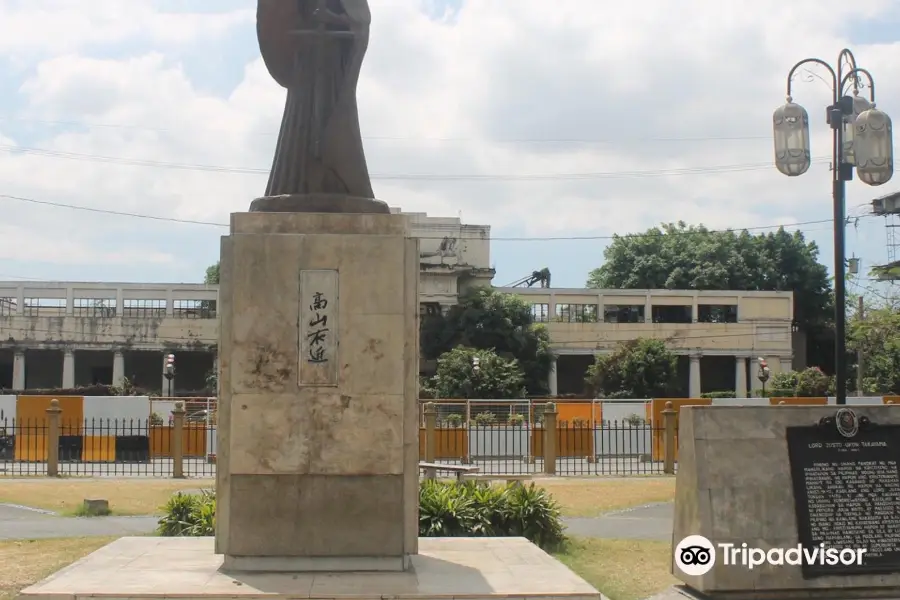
[{"x1": 419, "y1": 481, "x2": 565, "y2": 549}]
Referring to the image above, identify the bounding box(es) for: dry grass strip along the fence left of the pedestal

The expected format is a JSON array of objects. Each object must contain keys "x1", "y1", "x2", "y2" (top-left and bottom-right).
[{"x1": 0, "y1": 477, "x2": 215, "y2": 515}]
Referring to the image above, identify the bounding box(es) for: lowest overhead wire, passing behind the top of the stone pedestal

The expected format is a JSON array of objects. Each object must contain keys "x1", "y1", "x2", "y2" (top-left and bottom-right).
[{"x1": 0, "y1": 194, "x2": 860, "y2": 242}]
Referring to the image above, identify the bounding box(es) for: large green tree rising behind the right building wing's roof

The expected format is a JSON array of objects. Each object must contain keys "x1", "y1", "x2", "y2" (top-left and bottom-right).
[{"x1": 587, "y1": 222, "x2": 834, "y2": 369}]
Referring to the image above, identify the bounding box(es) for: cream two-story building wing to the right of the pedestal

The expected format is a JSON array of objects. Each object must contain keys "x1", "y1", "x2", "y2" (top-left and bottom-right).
[{"x1": 499, "y1": 288, "x2": 793, "y2": 398}]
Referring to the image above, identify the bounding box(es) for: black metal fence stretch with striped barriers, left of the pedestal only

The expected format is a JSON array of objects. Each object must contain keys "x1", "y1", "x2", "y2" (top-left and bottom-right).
[{"x1": 0, "y1": 418, "x2": 216, "y2": 477}]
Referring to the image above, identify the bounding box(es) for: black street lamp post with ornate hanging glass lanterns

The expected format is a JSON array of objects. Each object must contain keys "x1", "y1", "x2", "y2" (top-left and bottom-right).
[{"x1": 773, "y1": 49, "x2": 894, "y2": 404}]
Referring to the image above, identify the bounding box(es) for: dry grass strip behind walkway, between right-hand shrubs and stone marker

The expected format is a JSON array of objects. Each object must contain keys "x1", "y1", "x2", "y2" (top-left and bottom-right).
[{"x1": 537, "y1": 476, "x2": 675, "y2": 517}]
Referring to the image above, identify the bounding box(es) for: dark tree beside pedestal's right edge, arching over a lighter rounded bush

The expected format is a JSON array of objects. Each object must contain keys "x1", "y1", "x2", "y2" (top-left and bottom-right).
[{"x1": 420, "y1": 287, "x2": 553, "y2": 396}]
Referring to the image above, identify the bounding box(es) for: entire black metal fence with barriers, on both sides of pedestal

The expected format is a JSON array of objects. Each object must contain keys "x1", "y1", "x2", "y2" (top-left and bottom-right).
[{"x1": 0, "y1": 400, "x2": 677, "y2": 478}]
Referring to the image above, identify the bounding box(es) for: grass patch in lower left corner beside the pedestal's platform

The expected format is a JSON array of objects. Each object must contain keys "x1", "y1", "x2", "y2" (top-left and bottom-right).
[{"x1": 0, "y1": 537, "x2": 115, "y2": 600}]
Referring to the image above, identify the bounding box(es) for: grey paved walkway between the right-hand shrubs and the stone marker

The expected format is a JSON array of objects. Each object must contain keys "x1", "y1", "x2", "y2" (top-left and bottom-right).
[{"x1": 565, "y1": 502, "x2": 674, "y2": 542}]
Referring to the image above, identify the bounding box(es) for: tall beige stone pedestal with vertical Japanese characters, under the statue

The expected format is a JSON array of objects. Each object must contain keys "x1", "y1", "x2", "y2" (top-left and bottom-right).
[{"x1": 216, "y1": 212, "x2": 419, "y2": 572}]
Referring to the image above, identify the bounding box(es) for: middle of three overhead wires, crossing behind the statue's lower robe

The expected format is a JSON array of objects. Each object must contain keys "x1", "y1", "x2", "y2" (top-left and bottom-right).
[{"x1": 0, "y1": 144, "x2": 830, "y2": 181}]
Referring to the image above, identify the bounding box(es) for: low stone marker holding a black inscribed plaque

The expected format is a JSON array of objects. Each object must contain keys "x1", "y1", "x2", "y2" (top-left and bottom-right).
[{"x1": 672, "y1": 405, "x2": 900, "y2": 600}]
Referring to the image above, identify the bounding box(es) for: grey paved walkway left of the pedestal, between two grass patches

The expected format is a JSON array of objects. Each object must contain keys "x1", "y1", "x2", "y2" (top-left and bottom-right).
[{"x1": 0, "y1": 504, "x2": 159, "y2": 540}]
